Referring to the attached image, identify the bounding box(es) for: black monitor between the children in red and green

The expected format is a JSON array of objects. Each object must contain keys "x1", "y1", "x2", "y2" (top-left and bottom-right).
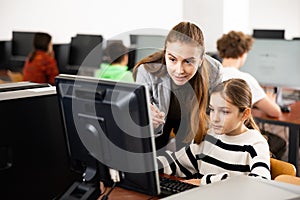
[{"x1": 69, "y1": 34, "x2": 103, "y2": 67}]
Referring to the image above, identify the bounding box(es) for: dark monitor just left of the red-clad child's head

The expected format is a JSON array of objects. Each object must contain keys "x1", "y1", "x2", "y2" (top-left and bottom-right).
[{"x1": 12, "y1": 31, "x2": 35, "y2": 56}]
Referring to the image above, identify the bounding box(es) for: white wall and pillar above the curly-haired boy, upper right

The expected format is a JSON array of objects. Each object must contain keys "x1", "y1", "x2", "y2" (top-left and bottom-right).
[{"x1": 183, "y1": 0, "x2": 300, "y2": 51}]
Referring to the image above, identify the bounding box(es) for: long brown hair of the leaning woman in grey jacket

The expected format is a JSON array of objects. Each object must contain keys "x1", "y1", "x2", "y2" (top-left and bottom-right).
[{"x1": 133, "y1": 22, "x2": 209, "y2": 143}]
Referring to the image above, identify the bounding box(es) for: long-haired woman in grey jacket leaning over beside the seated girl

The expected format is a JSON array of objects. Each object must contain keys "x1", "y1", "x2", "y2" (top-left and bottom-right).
[{"x1": 133, "y1": 22, "x2": 221, "y2": 150}]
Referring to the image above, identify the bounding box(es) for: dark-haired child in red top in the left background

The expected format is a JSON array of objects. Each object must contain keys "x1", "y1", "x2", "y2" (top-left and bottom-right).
[{"x1": 23, "y1": 32, "x2": 59, "y2": 85}]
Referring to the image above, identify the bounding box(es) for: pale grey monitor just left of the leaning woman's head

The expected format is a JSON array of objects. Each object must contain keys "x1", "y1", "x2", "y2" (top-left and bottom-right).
[{"x1": 130, "y1": 34, "x2": 166, "y2": 63}]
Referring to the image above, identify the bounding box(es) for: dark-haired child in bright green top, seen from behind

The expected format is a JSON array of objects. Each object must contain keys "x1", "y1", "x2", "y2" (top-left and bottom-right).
[{"x1": 95, "y1": 42, "x2": 134, "y2": 82}]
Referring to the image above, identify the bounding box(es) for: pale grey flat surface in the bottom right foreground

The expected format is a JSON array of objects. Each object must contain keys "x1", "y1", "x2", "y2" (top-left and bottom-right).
[{"x1": 164, "y1": 176, "x2": 300, "y2": 200}]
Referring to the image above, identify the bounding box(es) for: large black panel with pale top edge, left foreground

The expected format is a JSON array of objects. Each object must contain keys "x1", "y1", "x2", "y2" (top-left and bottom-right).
[{"x1": 0, "y1": 87, "x2": 80, "y2": 200}]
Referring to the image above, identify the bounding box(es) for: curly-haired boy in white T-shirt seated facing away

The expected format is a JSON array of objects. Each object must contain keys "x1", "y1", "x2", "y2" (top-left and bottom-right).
[{"x1": 217, "y1": 31, "x2": 281, "y2": 117}]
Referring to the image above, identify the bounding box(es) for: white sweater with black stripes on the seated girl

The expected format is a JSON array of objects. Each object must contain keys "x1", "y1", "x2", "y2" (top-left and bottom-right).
[{"x1": 158, "y1": 130, "x2": 271, "y2": 185}]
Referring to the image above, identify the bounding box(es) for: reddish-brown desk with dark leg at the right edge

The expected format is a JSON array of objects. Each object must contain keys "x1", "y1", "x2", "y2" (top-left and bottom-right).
[{"x1": 252, "y1": 101, "x2": 300, "y2": 175}]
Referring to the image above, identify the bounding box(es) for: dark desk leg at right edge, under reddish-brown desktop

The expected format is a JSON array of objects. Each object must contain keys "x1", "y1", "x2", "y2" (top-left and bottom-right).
[{"x1": 289, "y1": 125, "x2": 300, "y2": 176}]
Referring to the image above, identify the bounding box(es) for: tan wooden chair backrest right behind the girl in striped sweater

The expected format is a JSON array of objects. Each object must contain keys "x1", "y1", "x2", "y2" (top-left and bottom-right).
[{"x1": 270, "y1": 158, "x2": 296, "y2": 180}]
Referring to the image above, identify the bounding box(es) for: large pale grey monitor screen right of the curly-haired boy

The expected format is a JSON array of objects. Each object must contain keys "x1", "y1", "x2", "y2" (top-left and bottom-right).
[{"x1": 241, "y1": 39, "x2": 300, "y2": 89}]
